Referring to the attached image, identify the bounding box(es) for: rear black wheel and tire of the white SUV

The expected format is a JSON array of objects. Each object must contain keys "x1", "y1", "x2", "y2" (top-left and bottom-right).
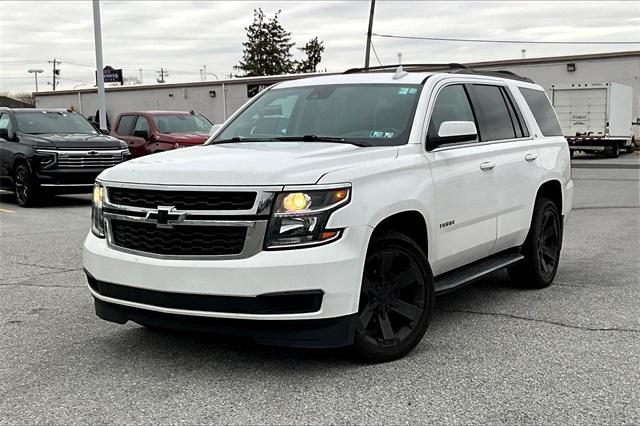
[{"x1": 508, "y1": 197, "x2": 562, "y2": 288}]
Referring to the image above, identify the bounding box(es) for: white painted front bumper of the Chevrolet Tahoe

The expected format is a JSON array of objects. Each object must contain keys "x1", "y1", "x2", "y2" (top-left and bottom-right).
[{"x1": 83, "y1": 226, "x2": 372, "y2": 322}]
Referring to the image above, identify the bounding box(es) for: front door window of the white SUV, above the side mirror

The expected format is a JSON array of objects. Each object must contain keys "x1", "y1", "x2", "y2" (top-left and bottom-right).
[{"x1": 427, "y1": 84, "x2": 475, "y2": 141}]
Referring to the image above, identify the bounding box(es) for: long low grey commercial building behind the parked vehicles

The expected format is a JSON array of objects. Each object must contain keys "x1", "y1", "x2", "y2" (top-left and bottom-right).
[{"x1": 34, "y1": 51, "x2": 640, "y2": 123}]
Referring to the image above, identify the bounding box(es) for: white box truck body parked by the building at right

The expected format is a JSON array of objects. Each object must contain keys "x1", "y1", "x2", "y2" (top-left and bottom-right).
[{"x1": 551, "y1": 82, "x2": 636, "y2": 157}]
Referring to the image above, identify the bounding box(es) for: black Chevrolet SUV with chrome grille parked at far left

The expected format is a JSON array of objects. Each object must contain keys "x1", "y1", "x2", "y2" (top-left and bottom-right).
[{"x1": 0, "y1": 108, "x2": 129, "y2": 207}]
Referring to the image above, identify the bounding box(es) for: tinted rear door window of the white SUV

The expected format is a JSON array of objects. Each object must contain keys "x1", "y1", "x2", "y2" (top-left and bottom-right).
[{"x1": 473, "y1": 84, "x2": 516, "y2": 141}]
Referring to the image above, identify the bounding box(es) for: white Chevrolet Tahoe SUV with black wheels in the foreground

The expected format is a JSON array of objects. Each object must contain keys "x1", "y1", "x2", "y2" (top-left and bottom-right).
[{"x1": 84, "y1": 69, "x2": 573, "y2": 361}]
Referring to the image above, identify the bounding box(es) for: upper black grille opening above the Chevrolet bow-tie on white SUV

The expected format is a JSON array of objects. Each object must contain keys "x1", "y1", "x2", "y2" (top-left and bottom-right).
[{"x1": 107, "y1": 188, "x2": 256, "y2": 210}]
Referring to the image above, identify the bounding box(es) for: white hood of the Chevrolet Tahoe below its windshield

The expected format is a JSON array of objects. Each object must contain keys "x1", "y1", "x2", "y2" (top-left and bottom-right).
[{"x1": 99, "y1": 142, "x2": 398, "y2": 186}]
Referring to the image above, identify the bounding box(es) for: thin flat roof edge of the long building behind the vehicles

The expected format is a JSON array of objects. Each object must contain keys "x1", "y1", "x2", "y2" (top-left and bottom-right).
[{"x1": 33, "y1": 50, "x2": 640, "y2": 96}]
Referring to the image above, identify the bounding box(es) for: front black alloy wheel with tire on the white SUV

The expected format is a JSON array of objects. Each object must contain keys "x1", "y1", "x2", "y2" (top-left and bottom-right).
[{"x1": 355, "y1": 232, "x2": 434, "y2": 361}]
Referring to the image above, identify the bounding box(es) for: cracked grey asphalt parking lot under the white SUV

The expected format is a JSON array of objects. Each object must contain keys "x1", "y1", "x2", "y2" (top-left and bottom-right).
[{"x1": 0, "y1": 152, "x2": 640, "y2": 424}]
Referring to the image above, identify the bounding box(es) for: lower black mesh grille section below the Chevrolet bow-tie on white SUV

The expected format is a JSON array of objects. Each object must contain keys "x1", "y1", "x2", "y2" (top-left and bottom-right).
[{"x1": 111, "y1": 219, "x2": 247, "y2": 256}]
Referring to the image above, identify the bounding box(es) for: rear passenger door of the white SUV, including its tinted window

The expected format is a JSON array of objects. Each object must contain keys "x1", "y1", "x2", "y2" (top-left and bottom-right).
[{"x1": 469, "y1": 84, "x2": 540, "y2": 253}]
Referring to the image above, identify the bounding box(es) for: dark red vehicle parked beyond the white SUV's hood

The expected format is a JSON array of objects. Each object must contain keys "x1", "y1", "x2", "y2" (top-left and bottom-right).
[{"x1": 111, "y1": 111, "x2": 213, "y2": 157}]
